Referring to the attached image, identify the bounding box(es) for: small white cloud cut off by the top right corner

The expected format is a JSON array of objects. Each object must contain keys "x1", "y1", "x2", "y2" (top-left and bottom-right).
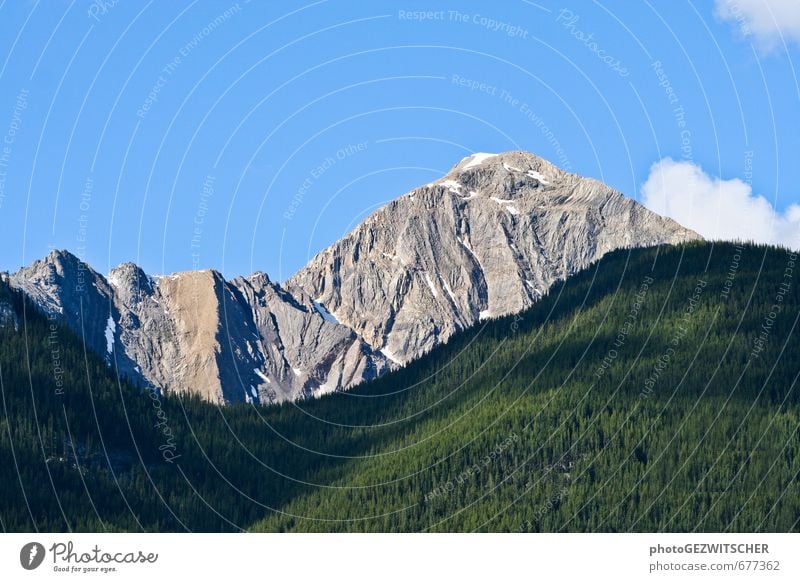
[{"x1": 714, "y1": 0, "x2": 800, "y2": 51}]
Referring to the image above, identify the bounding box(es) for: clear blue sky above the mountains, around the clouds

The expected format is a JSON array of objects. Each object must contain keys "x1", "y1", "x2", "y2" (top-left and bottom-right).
[{"x1": 0, "y1": 0, "x2": 800, "y2": 280}]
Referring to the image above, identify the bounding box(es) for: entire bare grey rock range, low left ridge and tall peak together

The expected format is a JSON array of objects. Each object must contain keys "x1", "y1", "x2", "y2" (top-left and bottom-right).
[{"x1": 10, "y1": 152, "x2": 700, "y2": 403}]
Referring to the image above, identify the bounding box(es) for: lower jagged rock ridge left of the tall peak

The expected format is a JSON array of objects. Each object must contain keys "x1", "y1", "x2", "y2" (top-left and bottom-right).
[{"x1": 9, "y1": 251, "x2": 387, "y2": 403}]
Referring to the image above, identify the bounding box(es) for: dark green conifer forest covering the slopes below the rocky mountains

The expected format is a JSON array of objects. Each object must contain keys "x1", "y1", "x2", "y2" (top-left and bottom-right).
[{"x1": 0, "y1": 243, "x2": 800, "y2": 532}]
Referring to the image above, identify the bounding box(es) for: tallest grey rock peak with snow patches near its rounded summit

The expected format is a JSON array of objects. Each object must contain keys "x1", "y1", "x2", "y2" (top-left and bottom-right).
[{"x1": 289, "y1": 152, "x2": 700, "y2": 362}]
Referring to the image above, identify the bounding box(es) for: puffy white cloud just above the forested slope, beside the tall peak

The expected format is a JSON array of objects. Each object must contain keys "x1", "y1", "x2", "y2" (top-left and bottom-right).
[{"x1": 642, "y1": 158, "x2": 800, "y2": 249}]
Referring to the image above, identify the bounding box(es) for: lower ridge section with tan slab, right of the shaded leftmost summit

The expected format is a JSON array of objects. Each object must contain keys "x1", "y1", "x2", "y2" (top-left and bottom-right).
[{"x1": 104, "y1": 263, "x2": 386, "y2": 403}]
